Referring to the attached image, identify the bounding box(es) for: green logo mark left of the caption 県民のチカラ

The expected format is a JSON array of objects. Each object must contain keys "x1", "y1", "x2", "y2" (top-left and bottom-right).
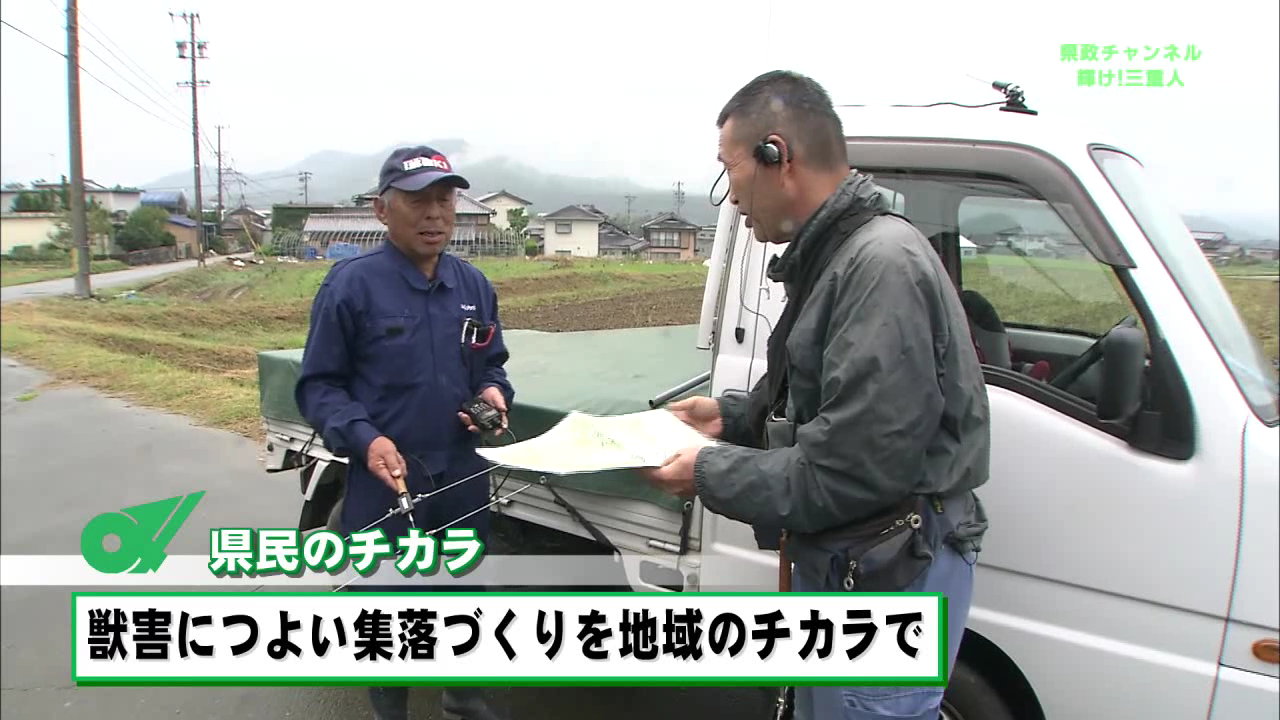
[{"x1": 81, "y1": 491, "x2": 205, "y2": 575}]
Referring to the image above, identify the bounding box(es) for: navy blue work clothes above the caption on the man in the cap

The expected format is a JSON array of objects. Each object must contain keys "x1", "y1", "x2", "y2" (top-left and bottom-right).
[{"x1": 294, "y1": 241, "x2": 515, "y2": 538}]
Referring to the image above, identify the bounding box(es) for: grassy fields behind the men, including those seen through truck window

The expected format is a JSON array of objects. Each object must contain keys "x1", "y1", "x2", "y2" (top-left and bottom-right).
[{"x1": 0, "y1": 256, "x2": 1280, "y2": 437}]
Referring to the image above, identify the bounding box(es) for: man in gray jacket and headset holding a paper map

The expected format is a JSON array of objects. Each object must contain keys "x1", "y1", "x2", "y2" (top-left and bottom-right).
[{"x1": 649, "y1": 72, "x2": 989, "y2": 720}]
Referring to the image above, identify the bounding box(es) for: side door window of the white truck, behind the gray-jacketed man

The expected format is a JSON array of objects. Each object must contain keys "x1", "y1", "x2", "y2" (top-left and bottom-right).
[{"x1": 874, "y1": 168, "x2": 1149, "y2": 423}]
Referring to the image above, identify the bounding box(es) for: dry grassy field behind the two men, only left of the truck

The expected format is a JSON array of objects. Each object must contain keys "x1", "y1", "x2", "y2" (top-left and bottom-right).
[{"x1": 0, "y1": 260, "x2": 707, "y2": 437}]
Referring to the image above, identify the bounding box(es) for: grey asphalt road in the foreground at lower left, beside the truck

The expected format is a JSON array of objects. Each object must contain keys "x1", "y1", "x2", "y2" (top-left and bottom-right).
[{"x1": 0, "y1": 360, "x2": 765, "y2": 720}]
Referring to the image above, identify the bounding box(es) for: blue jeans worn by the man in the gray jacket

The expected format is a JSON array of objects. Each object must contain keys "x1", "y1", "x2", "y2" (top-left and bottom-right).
[{"x1": 791, "y1": 546, "x2": 975, "y2": 720}]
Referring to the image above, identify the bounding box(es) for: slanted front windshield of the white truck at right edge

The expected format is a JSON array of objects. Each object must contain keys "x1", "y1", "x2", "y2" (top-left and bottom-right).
[{"x1": 1093, "y1": 147, "x2": 1280, "y2": 424}]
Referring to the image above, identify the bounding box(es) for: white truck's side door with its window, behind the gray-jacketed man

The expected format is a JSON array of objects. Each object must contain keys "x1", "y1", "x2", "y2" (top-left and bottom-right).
[{"x1": 704, "y1": 138, "x2": 1240, "y2": 719}]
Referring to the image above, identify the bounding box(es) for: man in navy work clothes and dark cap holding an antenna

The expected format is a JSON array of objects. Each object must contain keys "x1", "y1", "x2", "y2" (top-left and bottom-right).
[{"x1": 296, "y1": 146, "x2": 515, "y2": 720}]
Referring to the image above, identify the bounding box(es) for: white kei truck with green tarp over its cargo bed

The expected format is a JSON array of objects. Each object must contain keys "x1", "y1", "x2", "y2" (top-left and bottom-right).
[{"x1": 260, "y1": 87, "x2": 1280, "y2": 720}]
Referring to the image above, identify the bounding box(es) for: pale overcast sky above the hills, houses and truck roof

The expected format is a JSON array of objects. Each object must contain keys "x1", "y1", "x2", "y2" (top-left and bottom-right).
[{"x1": 0, "y1": 0, "x2": 1280, "y2": 225}]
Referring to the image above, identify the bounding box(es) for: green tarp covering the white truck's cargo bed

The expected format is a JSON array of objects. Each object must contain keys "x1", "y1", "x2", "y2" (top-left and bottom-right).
[{"x1": 257, "y1": 325, "x2": 710, "y2": 510}]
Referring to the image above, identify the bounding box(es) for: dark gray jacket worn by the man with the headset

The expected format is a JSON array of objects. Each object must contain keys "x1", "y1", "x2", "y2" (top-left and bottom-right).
[{"x1": 694, "y1": 173, "x2": 991, "y2": 548}]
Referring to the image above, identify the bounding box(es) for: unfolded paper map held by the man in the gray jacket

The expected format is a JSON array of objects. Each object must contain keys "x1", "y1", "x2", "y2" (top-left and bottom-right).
[{"x1": 476, "y1": 409, "x2": 717, "y2": 475}]
